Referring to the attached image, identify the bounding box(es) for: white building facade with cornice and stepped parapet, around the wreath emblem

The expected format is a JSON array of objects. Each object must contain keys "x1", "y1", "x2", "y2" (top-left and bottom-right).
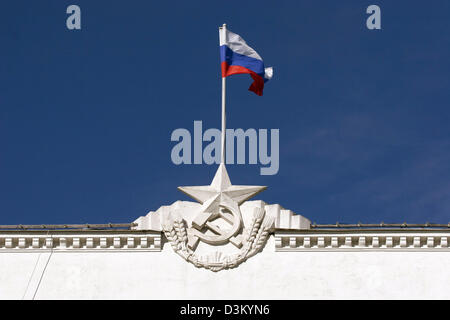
[{"x1": 0, "y1": 201, "x2": 450, "y2": 299}]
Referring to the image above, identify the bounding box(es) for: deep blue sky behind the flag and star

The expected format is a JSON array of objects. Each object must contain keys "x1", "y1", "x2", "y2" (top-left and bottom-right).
[{"x1": 0, "y1": 0, "x2": 450, "y2": 224}]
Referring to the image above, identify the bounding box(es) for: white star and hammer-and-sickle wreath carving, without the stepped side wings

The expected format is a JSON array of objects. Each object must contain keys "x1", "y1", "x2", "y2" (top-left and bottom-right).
[{"x1": 161, "y1": 164, "x2": 275, "y2": 271}]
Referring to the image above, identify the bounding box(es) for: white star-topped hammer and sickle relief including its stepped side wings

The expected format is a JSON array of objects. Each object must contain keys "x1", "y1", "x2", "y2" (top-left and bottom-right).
[{"x1": 128, "y1": 163, "x2": 311, "y2": 272}]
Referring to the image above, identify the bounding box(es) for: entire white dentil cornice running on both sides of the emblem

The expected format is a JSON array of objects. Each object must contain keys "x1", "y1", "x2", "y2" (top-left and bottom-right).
[{"x1": 0, "y1": 229, "x2": 450, "y2": 253}]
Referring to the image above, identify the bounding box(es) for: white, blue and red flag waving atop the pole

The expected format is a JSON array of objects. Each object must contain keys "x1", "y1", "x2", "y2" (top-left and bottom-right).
[{"x1": 219, "y1": 25, "x2": 273, "y2": 96}]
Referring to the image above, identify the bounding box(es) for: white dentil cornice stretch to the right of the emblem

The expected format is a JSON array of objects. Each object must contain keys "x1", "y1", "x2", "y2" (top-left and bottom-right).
[{"x1": 274, "y1": 230, "x2": 450, "y2": 252}]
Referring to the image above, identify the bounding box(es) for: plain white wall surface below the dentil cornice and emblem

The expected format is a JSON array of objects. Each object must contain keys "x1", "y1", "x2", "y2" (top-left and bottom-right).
[{"x1": 0, "y1": 236, "x2": 450, "y2": 299}]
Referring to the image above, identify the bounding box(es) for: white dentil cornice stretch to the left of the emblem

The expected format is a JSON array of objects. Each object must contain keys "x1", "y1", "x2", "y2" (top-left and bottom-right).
[{"x1": 0, "y1": 231, "x2": 161, "y2": 252}]
